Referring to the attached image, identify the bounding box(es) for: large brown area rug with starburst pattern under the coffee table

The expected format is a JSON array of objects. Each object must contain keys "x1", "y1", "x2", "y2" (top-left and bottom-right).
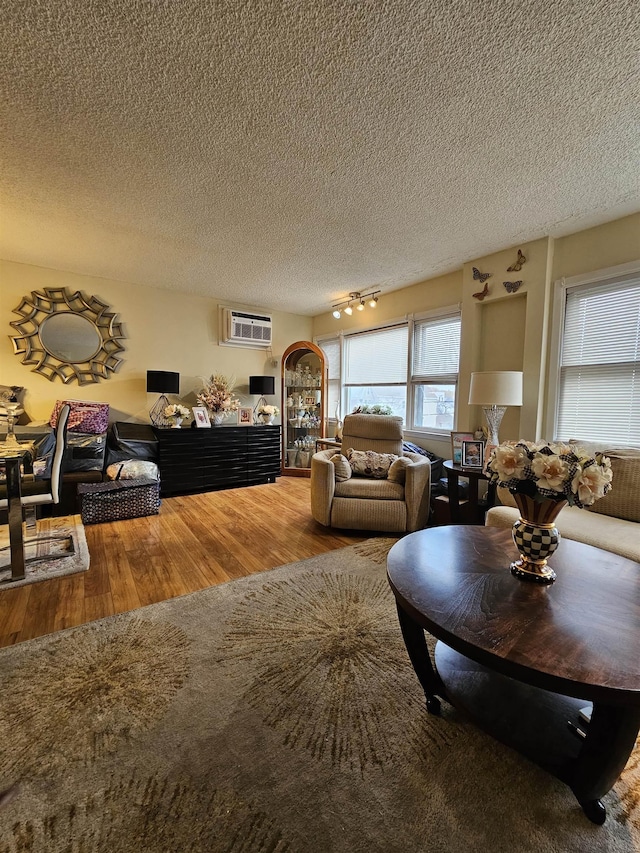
[{"x1": 0, "y1": 539, "x2": 640, "y2": 853}]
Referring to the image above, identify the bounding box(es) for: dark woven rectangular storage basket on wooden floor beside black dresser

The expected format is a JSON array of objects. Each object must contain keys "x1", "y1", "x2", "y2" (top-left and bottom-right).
[{"x1": 78, "y1": 478, "x2": 160, "y2": 524}]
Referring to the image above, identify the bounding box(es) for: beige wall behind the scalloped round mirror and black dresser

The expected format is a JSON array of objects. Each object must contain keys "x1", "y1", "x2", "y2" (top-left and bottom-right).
[{"x1": 0, "y1": 261, "x2": 312, "y2": 422}]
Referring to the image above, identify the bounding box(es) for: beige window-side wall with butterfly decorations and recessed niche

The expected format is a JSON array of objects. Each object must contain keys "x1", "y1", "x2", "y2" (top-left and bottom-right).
[{"x1": 313, "y1": 213, "x2": 640, "y2": 456}]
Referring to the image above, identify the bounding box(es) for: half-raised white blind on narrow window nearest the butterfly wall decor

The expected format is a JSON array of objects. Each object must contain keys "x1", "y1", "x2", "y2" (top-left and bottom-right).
[{"x1": 411, "y1": 314, "x2": 460, "y2": 382}]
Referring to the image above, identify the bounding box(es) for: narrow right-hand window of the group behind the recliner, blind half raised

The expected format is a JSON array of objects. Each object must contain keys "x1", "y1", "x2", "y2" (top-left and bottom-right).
[{"x1": 411, "y1": 314, "x2": 460, "y2": 431}]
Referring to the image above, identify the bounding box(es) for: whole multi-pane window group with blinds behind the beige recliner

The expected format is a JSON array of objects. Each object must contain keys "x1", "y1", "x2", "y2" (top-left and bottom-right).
[{"x1": 318, "y1": 310, "x2": 460, "y2": 433}]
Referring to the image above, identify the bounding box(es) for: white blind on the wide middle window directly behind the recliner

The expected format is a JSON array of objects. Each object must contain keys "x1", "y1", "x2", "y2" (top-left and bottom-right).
[{"x1": 344, "y1": 325, "x2": 408, "y2": 385}]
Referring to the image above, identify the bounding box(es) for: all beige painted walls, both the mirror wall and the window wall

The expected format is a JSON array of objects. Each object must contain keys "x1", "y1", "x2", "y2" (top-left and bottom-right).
[{"x1": 0, "y1": 213, "x2": 640, "y2": 446}]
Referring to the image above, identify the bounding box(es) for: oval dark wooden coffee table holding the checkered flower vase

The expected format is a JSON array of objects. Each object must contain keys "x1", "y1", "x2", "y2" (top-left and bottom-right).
[{"x1": 387, "y1": 525, "x2": 640, "y2": 824}]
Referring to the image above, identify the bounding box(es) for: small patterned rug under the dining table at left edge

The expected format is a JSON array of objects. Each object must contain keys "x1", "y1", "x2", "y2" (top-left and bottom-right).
[{"x1": 0, "y1": 515, "x2": 89, "y2": 590}]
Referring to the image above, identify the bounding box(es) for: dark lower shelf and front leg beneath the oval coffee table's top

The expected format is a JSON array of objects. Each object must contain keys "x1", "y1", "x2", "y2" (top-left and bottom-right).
[{"x1": 430, "y1": 642, "x2": 640, "y2": 824}]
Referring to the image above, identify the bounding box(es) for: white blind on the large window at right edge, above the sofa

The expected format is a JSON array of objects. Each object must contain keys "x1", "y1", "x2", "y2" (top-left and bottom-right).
[{"x1": 556, "y1": 275, "x2": 640, "y2": 446}]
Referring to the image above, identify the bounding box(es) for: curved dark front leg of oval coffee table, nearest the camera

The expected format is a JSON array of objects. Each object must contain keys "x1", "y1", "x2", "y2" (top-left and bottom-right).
[{"x1": 563, "y1": 703, "x2": 640, "y2": 824}]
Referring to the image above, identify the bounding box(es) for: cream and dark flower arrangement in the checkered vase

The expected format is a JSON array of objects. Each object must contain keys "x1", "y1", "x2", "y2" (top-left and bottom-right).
[{"x1": 486, "y1": 440, "x2": 613, "y2": 509}]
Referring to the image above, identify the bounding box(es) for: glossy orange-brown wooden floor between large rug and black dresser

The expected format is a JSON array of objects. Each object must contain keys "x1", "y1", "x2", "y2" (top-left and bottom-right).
[{"x1": 0, "y1": 477, "x2": 372, "y2": 647}]
